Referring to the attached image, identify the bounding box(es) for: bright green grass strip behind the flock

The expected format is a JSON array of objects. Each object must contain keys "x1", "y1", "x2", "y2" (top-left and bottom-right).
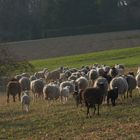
[{"x1": 31, "y1": 47, "x2": 140, "y2": 70}]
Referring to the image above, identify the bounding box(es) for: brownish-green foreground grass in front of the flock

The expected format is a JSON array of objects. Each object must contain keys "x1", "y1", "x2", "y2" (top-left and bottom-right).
[{"x1": 0, "y1": 91, "x2": 140, "y2": 140}]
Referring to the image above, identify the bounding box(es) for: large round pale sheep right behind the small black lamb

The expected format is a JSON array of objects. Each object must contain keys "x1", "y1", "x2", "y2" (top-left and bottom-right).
[{"x1": 110, "y1": 76, "x2": 128, "y2": 98}]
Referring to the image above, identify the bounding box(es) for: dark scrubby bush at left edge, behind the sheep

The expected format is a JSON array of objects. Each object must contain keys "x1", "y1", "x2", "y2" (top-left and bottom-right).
[{"x1": 0, "y1": 47, "x2": 34, "y2": 77}]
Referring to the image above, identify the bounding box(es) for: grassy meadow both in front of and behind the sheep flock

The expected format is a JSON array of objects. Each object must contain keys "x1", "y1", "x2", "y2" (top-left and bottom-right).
[{"x1": 0, "y1": 47, "x2": 140, "y2": 140}]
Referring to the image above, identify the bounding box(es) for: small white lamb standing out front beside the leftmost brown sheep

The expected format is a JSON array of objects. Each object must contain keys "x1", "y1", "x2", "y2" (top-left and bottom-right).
[{"x1": 21, "y1": 91, "x2": 30, "y2": 112}]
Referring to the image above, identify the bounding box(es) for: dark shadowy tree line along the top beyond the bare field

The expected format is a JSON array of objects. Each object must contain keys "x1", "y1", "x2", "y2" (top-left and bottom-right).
[{"x1": 0, "y1": 0, "x2": 140, "y2": 42}]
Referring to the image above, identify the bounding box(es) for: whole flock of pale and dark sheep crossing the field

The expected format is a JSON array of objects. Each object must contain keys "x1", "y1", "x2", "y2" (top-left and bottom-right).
[{"x1": 7, "y1": 64, "x2": 140, "y2": 117}]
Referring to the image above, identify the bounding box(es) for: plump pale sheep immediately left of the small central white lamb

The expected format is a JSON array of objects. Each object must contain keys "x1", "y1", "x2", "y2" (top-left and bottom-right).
[{"x1": 43, "y1": 84, "x2": 60, "y2": 100}]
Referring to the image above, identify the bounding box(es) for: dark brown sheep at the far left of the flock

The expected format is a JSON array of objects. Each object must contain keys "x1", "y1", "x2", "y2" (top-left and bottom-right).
[{"x1": 6, "y1": 80, "x2": 21, "y2": 103}]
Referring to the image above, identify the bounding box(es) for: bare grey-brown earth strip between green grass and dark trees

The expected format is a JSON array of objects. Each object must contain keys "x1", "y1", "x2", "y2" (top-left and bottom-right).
[{"x1": 0, "y1": 30, "x2": 140, "y2": 60}]
